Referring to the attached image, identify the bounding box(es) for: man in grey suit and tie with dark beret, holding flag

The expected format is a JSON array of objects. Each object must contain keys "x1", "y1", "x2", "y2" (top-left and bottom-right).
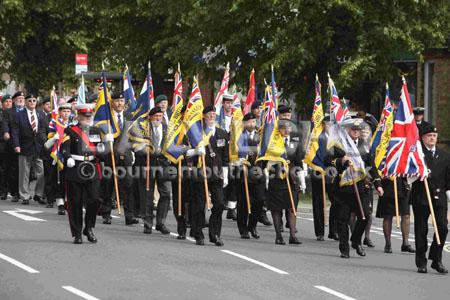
[{"x1": 129, "y1": 107, "x2": 172, "y2": 234}]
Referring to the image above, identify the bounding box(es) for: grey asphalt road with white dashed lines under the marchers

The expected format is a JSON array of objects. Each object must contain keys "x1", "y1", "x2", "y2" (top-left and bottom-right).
[{"x1": 0, "y1": 200, "x2": 450, "y2": 300}]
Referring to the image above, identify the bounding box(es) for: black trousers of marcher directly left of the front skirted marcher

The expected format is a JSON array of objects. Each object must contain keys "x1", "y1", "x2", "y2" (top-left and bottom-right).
[{"x1": 235, "y1": 180, "x2": 266, "y2": 234}]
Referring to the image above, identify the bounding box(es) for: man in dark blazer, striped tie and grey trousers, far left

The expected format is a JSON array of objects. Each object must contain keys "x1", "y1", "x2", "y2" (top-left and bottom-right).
[{"x1": 12, "y1": 95, "x2": 47, "y2": 204}]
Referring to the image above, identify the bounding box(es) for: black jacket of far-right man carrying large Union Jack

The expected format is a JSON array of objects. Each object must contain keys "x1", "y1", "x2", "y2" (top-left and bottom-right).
[{"x1": 411, "y1": 146, "x2": 450, "y2": 208}]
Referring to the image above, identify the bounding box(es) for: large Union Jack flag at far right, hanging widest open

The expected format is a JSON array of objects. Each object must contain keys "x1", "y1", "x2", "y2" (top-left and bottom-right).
[{"x1": 383, "y1": 78, "x2": 428, "y2": 179}]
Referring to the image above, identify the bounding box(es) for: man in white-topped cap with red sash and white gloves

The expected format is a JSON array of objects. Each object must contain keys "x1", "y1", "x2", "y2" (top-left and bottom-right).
[{"x1": 61, "y1": 104, "x2": 109, "y2": 244}]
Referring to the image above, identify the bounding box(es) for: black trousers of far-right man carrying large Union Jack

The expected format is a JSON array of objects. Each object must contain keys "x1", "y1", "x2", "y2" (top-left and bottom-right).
[{"x1": 413, "y1": 204, "x2": 448, "y2": 268}]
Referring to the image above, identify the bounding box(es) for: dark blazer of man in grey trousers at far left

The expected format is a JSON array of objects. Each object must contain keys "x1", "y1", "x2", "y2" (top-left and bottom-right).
[{"x1": 11, "y1": 109, "x2": 48, "y2": 156}]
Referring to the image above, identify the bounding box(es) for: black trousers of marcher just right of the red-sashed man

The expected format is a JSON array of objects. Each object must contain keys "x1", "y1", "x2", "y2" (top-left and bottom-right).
[{"x1": 102, "y1": 161, "x2": 134, "y2": 220}]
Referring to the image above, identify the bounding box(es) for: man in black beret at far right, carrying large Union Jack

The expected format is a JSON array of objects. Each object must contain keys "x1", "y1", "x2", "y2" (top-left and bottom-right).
[{"x1": 411, "y1": 124, "x2": 450, "y2": 274}]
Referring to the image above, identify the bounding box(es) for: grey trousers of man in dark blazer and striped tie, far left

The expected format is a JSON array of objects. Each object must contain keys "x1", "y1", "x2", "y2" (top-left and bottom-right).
[{"x1": 19, "y1": 155, "x2": 44, "y2": 199}]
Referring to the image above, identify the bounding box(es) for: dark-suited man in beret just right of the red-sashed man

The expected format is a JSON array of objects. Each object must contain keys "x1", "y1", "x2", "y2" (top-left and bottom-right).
[{"x1": 102, "y1": 93, "x2": 139, "y2": 225}]
